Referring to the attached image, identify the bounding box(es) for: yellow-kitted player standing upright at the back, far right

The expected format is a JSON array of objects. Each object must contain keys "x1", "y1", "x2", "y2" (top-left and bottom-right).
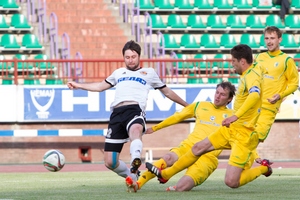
[{"x1": 255, "y1": 26, "x2": 299, "y2": 142}]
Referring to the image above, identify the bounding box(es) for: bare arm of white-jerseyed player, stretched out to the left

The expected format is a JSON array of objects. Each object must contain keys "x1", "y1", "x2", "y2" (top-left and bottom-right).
[{"x1": 67, "y1": 80, "x2": 113, "y2": 92}]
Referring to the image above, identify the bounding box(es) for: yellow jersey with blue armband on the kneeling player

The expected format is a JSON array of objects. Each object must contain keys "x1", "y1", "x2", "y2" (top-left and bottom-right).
[{"x1": 233, "y1": 63, "x2": 263, "y2": 130}]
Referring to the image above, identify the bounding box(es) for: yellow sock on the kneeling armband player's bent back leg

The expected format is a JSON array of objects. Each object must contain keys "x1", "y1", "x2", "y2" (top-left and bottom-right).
[{"x1": 240, "y1": 166, "x2": 268, "y2": 186}]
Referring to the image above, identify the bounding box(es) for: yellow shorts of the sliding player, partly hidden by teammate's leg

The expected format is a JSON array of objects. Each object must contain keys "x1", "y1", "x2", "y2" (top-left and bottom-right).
[{"x1": 171, "y1": 140, "x2": 221, "y2": 186}]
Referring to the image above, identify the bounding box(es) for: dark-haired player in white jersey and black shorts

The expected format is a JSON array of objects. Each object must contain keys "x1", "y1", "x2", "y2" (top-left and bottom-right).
[{"x1": 67, "y1": 40, "x2": 188, "y2": 184}]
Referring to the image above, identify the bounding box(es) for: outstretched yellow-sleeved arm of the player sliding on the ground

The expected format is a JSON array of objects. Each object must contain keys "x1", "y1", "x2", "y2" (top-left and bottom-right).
[{"x1": 147, "y1": 103, "x2": 196, "y2": 134}]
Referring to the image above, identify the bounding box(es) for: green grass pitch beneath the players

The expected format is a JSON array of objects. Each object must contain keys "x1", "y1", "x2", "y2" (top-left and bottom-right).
[{"x1": 0, "y1": 168, "x2": 300, "y2": 200}]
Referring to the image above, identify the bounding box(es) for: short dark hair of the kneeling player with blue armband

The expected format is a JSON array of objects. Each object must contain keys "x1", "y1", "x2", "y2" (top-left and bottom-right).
[{"x1": 230, "y1": 44, "x2": 253, "y2": 64}]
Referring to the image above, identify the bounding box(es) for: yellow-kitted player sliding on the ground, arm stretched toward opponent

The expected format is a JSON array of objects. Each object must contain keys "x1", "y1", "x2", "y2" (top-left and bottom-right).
[{"x1": 126, "y1": 82, "x2": 236, "y2": 191}]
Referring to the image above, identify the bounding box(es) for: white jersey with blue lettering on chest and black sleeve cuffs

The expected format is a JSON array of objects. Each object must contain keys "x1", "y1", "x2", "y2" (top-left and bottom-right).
[{"x1": 106, "y1": 68, "x2": 165, "y2": 111}]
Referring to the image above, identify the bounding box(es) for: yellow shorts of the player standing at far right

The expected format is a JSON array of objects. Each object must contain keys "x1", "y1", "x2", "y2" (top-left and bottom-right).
[{"x1": 255, "y1": 108, "x2": 276, "y2": 141}]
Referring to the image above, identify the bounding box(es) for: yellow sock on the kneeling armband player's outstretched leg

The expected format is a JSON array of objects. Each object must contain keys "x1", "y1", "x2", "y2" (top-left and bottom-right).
[{"x1": 161, "y1": 150, "x2": 200, "y2": 180}]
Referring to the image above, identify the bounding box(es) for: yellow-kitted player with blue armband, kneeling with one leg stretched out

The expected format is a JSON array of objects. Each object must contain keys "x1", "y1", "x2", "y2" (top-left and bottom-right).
[{"x1": 146, "y1": 44, "x2": 272, "y2": 188}]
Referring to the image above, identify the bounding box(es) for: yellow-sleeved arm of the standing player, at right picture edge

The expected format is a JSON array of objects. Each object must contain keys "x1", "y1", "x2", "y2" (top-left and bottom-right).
[{"x1": 280, "y1": 58, "x2": 299, "y2": 98}]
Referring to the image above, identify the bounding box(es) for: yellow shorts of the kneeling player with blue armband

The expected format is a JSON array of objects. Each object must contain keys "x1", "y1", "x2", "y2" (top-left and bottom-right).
[{"x1": 208, "y1": 125, "x2": 259, "y2": 168}]
